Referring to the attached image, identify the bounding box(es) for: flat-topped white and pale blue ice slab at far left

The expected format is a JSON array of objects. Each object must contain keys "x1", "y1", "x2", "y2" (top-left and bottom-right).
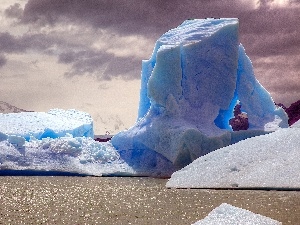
[{"x1": 0, "y1": 109, "x2": 94, "y2": 140}]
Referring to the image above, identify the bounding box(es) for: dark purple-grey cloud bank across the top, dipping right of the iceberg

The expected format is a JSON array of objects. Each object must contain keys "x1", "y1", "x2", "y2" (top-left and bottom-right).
[{"x1": 22, "y1": 0, "x2": 300, "y2": 56}]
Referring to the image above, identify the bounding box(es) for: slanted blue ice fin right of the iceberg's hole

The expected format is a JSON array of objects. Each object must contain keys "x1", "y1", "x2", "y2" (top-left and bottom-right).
[{"x1": 235, "y1": 45, "x2": 288, "y2": 130}]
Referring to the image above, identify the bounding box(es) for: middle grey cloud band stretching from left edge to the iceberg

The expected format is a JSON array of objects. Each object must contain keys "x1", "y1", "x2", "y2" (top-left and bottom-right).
[{"x1": 0, "y1": 25, "x2": 140, "y2": 80}]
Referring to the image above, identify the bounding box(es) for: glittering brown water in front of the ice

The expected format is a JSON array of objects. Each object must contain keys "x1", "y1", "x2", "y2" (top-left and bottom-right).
[{"x1": 0, "y1": 176, "x2": 300, "y2": 225}]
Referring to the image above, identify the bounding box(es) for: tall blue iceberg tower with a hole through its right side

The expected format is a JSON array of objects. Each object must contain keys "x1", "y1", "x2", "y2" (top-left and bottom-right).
[{"x1": 111, "y1": 18, "x2": 288, "y2": 169}]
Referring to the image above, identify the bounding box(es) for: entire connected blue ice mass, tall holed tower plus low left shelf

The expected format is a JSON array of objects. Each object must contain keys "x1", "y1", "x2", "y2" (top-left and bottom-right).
[{"x1": 0, "y1": 18, "x2": 288, "y2": 181}]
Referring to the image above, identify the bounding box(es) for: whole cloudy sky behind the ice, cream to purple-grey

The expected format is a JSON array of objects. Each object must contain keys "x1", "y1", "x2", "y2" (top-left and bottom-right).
[{"x1": 0, "y1": 0, "x2": 300, "y2": 133}]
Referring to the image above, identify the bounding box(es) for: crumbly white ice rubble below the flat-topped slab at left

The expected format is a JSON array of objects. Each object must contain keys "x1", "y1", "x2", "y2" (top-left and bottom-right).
[{"x1": 0, "y1": 136, "x2": 135, "y2": 176}]
